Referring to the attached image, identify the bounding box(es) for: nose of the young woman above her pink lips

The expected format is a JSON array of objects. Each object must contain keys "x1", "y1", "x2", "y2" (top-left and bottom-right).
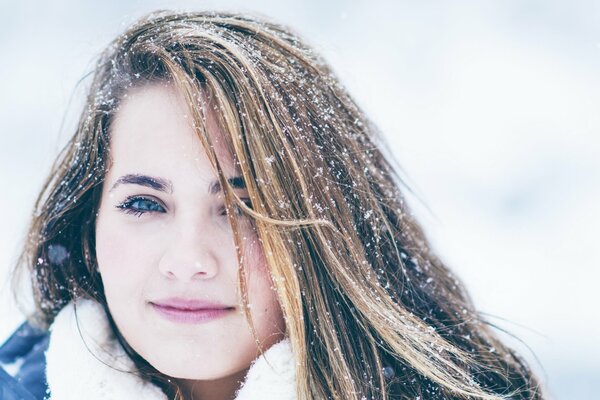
[{"x1": 158, "y1": 222, "x2": 219, "y2": 282}]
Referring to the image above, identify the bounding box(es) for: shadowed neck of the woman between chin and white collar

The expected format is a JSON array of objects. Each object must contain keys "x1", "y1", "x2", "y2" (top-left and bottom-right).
[{"x1": 177, "y1": 369, "x2": 248, "y2": 400}]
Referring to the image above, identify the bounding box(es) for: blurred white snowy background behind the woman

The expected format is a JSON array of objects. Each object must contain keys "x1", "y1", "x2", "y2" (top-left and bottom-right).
[{"x1": 0, "y1": 0, "x2": 600, "y2": 400}]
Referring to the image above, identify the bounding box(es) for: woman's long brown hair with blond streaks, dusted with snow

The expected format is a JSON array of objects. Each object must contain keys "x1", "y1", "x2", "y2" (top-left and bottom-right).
[{"x1": 18, "y1": 11, "x2": 542, "y2": 399}]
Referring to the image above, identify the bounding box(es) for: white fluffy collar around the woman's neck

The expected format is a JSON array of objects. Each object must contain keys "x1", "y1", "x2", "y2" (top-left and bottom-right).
[{"x1": 46, "y1": 300, "x2": 296, "y2": 400}]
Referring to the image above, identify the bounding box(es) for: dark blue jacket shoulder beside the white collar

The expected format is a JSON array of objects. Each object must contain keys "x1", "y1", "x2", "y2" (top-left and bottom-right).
[{"x1": 0, "y1": 322, "x2": 50, "y2": 400}]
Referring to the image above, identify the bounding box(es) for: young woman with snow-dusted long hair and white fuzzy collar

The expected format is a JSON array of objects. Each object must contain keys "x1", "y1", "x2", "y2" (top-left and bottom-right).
[{"x1": 0, "y1": 12, "x2": 542, "y2": 400}]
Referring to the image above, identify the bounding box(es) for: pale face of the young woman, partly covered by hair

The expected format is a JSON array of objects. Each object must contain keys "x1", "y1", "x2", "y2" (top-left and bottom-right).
[{"x1": 96, "y1": 84, "x2": 285, "y2": 380}]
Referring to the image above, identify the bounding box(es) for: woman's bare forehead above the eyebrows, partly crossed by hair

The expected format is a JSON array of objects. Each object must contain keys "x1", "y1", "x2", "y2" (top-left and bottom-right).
[{"x1": 110, "y1": 83, "x2": 233, "y2": 170}]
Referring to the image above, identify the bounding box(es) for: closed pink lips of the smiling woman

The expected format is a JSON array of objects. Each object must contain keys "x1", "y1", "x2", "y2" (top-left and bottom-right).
[{"x1": 150, "y1": 297, "x2": 234, "y2": 324}]
